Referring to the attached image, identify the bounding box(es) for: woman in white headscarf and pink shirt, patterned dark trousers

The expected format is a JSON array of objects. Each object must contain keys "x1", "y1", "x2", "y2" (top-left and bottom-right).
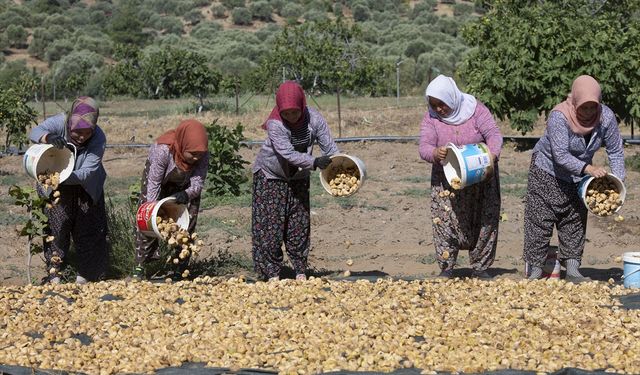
[{"x1": 419, "y1": 75, "x2": 502, "y2": 278}]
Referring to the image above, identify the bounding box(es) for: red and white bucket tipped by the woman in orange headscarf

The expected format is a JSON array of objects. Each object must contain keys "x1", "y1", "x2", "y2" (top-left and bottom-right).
[{"x1": 136, "y1": 197, "x2": 190, "y2": 238}]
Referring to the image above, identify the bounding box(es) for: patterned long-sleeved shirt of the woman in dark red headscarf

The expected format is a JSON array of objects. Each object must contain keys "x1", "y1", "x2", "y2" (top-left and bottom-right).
[{"x1": 253, "y1": 107, "x2": 338, "y2": 180}]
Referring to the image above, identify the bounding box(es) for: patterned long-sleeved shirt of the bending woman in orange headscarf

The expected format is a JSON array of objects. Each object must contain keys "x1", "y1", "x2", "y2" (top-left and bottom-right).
[{"x1": 142, "y1": 143, "x2": 209, "y2": 202}]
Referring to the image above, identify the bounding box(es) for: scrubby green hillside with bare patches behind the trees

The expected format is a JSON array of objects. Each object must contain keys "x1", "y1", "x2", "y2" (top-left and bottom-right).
[{"x1": 0, "y1": 0, "x2": 482, "y2": 97}]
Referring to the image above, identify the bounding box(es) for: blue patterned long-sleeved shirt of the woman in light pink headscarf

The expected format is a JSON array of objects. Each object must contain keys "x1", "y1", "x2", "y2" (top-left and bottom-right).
[{"x1": 533, "y1": 104, "x2": 626, "y2": 182}]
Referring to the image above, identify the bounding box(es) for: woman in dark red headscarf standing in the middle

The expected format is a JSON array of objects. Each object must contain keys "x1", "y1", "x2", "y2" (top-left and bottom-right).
[{"x1": 251, "y1": 81, "x2": 338, "y2": 280}]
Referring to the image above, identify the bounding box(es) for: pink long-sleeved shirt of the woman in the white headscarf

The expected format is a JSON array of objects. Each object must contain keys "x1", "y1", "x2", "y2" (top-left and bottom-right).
[{"x1": 419, "y1": 102, "x2": 502, "y2": 170}]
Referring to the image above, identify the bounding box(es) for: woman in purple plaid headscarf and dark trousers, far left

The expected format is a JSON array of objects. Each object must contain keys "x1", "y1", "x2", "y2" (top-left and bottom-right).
[{"x1": 29, "y1": 96, "x2": 107, "y2": 284}]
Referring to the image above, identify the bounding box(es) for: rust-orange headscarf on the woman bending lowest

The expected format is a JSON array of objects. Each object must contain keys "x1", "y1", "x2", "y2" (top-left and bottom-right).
[{"x1": 156, "y1": 119, "x2": 209, "y2": 171}]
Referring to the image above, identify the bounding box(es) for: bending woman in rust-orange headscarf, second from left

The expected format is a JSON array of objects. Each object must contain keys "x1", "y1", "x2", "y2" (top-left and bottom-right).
[{"x1": 133, "y1": 120, "x2": 209, "y2": 279}]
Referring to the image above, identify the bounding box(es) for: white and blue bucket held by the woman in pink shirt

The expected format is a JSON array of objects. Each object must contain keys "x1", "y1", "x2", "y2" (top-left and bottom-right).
[{"x1": 443, "y1": 143, "x2": 493, "y2": 189}]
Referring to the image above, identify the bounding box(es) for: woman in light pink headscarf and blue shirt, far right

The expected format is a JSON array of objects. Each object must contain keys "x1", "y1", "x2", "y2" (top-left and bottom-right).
[{"x1": 524, "y1": 75, "x2": 625, "y2": 282}]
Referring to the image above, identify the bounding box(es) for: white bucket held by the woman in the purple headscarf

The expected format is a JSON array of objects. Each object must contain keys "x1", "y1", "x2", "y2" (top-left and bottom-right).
[{"x1": 22, "y1": 143, "x2": 76, "y2": 182}]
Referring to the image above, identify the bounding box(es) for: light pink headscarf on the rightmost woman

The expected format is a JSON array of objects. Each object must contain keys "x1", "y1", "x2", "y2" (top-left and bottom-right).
[{"x1": 552, "y1": 75, "x2": 602, "y2": 135}]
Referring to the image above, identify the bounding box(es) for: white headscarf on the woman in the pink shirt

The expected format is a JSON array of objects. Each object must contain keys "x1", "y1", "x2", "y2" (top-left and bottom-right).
[{"x1": 425, "y1": 74, "x2": 478, "y2": 125}]
